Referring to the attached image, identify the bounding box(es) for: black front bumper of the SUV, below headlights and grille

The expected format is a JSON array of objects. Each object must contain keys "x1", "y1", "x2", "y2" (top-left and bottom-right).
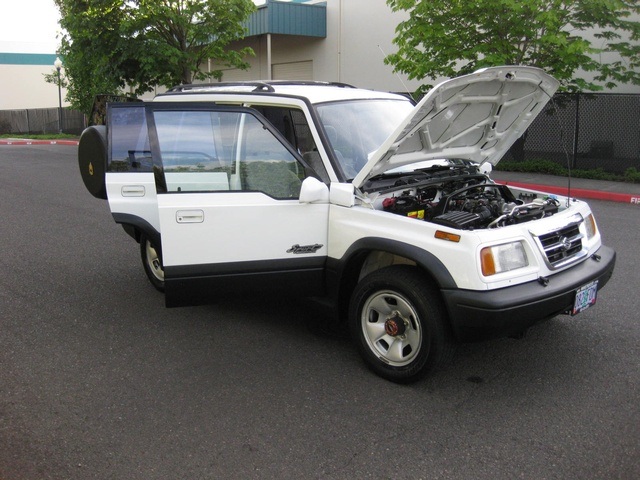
[{"x1": 442, "y1": 246, "x2": 616, "y2": 341}]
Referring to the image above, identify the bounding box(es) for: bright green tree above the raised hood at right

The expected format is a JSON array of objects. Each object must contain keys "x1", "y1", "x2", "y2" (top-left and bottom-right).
[{"x1": 385, "y1": 0, "x2": 640, "y2": 91}]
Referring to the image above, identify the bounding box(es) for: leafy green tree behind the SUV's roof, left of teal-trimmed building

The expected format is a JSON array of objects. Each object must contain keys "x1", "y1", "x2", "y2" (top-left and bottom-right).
[{"x1": 54, "y1": 0, "x2": 255, "y2": 113}]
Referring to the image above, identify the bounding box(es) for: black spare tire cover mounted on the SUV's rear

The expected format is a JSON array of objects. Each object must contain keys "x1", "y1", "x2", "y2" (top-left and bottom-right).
[{"x1": 78, "y1": 125, "x2": 107, "y2": 200}]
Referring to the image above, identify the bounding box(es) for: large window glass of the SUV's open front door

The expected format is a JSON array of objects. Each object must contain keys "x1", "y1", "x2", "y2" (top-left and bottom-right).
[{"x1": 153, "y1": 110, "x2": 305, "y2": 199}]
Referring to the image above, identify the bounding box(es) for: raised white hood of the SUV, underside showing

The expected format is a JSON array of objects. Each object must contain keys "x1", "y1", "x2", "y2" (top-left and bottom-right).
[{"x1": 353, "y1": 66, "x2": 559, "y2": 188}]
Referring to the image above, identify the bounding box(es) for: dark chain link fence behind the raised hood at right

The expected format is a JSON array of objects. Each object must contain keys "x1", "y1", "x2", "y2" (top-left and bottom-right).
[{"x1": 505, "y1": 93, "x2": 640, "y2": 174}]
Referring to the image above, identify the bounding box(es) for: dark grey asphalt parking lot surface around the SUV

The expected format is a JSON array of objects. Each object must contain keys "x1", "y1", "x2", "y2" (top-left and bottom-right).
[{"x1": 0, "y1": 145, "x2": 640, "y2": 480}]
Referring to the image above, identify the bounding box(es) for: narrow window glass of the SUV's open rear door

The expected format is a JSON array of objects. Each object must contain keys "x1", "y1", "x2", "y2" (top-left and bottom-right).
[{"x1": 107, "y1": 103, "x2": 153, "y2": 172}]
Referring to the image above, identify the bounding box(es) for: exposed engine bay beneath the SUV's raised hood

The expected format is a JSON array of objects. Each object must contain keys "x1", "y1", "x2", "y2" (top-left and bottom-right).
[{"x1": 366, "y1": 161, "x2": 560, "y2": 230}]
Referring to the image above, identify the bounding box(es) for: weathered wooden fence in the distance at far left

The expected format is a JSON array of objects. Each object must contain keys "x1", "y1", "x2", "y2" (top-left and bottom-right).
[{"x1": 0, "y1": 108, "x2": 86, "y2": 135}]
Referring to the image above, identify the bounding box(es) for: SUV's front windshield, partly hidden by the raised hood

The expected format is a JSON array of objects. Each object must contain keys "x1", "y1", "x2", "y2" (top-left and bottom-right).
[{"x1": 317, "y1": 100, "x2": 413, "y2": 179}]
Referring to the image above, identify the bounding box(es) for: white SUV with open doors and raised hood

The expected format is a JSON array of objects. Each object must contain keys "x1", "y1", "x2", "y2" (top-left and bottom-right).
[{"x1": 78, "y1": 67, "x2": 615, "y2": 382}]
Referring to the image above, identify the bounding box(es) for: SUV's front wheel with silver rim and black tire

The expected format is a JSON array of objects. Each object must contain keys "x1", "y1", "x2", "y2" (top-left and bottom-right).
[{"x1": 349, "y1": 265, "x2": 453, "y2": 383}]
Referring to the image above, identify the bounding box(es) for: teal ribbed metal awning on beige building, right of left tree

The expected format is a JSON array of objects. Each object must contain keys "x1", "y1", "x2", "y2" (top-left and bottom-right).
[{"x1": 245, "y1": 0, "x2": 327, "y2": 38}]
